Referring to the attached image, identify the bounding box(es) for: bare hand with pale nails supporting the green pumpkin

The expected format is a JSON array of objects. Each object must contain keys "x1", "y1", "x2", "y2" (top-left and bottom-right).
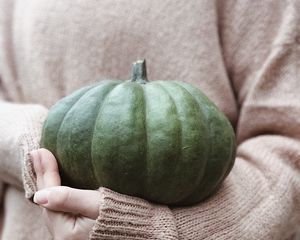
[{"x1": 30, "y1": 149, "x2": 101, "y2": 240}]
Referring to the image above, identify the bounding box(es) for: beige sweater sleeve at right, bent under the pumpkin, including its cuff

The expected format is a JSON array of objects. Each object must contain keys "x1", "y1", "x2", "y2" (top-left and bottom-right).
[{"x1": 90, "y1": 1, "x2": 300, "y2": 240}]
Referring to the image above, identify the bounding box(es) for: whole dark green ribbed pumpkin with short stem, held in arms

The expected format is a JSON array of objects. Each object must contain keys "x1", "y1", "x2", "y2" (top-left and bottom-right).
[{"x1": 41, "y1": 60, "x2": 236, "y2": 206}]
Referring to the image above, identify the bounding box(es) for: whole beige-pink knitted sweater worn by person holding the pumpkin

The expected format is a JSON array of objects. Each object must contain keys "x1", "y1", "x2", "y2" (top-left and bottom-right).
[{"x1": 0, "y1": 0, "x2": 300, "y2": 240}]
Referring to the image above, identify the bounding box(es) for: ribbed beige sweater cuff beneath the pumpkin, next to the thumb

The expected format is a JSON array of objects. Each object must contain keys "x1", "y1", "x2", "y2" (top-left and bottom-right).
[{"x1": 89, "y1": 187, "x2": 178, "y2": 240}]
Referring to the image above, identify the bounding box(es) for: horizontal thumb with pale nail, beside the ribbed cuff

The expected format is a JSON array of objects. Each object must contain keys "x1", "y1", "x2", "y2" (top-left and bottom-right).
[{"x1": 33, "y1": 186, "x2": 101, "y2": 219}]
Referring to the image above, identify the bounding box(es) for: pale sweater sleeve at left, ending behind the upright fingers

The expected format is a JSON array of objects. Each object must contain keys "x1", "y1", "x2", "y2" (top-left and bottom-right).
[{"x1": 0, "y1": 101, "x2": 47, "y2": 198}]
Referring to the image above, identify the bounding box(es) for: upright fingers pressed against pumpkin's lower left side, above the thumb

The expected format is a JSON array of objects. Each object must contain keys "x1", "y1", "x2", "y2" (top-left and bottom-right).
[{"x1": 30, "y1": 148, "x2": 61, "y2": 190}]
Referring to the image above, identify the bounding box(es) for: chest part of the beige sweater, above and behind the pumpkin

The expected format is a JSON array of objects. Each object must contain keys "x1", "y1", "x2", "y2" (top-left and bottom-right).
[{"x1": 0, "y1": 0, "x2": 237, "y2": 124}]
